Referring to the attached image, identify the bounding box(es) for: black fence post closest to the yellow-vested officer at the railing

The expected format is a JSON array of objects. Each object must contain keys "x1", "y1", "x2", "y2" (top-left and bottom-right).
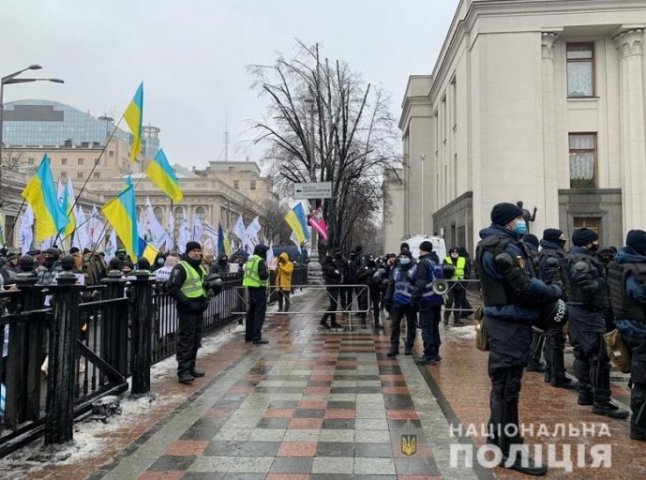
[{"x1": 130, "y1": 270, "x2": 153, "y2": 395}]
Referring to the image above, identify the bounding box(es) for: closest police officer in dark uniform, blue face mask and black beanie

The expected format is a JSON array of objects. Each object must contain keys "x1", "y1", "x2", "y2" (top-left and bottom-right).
[{"x1": 476, "y1": 203, "x2": 561, "y2": 475}]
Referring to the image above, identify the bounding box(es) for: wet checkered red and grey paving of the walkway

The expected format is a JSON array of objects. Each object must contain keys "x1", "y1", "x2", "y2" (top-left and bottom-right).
[{"x1": 2, "y1": 290, "x2": 646, "y2": 480}]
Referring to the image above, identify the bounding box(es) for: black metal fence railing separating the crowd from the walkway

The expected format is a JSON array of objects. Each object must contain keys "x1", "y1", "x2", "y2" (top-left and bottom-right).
[{"x1": 0, "y1": 268, "x2": 307, "y2": 457}]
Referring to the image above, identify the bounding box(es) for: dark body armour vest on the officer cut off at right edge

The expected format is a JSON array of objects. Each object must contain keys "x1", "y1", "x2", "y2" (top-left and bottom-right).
[{"x1": 608, "y1": 263, "x2": 646, "y2": 321}]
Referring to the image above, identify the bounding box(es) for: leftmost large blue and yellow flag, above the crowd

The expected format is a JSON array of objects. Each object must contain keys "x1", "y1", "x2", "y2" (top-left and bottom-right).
[{"x1": 22, "y1": 154, "x2": 69, "y2": 242}]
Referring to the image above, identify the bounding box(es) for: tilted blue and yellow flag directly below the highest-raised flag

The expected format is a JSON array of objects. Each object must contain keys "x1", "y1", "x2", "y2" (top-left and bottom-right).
[{"x1": 101, "y1": 177, "x2": 141, "y2": 259}]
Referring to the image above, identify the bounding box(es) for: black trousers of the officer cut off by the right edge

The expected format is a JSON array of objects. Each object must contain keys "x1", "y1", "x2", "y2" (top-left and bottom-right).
[{"x1": 621, "y1": 335, "x2": 646, "y2": 435}]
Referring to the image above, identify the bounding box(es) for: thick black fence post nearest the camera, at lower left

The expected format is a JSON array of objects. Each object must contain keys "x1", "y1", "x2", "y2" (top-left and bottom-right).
[{"x1": 45, "y1": 271, "x2": 83, "y2": 445}]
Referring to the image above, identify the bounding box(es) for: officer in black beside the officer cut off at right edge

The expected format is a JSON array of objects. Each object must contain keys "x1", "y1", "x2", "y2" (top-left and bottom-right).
[{"x1": 567, "y1": 228, "x2": 628, "y2": 418}]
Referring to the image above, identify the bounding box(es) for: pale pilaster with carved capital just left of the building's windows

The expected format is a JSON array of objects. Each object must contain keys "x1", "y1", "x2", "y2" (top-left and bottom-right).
[{"x1": 539, "y1": 32, "x2": 559, "y2": 228}]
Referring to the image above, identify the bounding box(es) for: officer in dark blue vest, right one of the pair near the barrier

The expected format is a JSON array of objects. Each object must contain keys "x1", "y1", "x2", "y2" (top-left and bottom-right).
[{"x1": 413, "y1": 240, "x2": 444, "y2": 365}]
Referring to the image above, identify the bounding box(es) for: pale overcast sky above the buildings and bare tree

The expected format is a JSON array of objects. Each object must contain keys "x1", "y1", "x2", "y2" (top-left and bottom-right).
[{"x1": 0, "y1": 0, "x2": 458, "y2": 171}]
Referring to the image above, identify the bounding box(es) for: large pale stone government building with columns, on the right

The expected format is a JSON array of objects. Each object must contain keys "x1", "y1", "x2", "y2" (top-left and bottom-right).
[{"x1": 385, "y1": 0, "x2": 646, "y2": 252}]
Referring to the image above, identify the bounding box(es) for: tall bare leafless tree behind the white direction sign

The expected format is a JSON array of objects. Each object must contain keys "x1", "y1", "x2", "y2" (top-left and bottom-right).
[{"x1": 250, "y1": 41, "x2": 399, "y2": 255}]
